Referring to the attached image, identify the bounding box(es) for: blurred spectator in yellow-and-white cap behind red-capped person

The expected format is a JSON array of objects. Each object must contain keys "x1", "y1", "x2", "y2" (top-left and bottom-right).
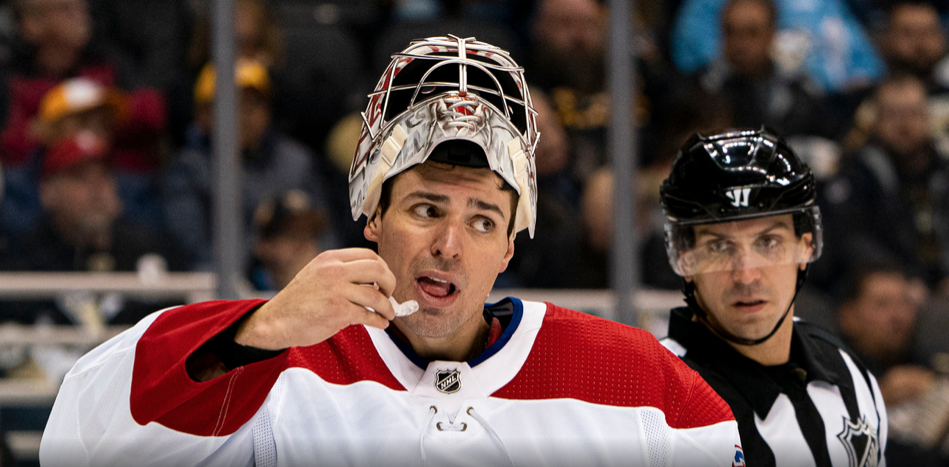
[{"x1": 0, "y1": 77, "x2": 161, "y2": 236}]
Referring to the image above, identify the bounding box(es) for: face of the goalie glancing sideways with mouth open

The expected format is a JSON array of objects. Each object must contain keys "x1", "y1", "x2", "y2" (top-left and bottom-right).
[{"x1": 365, "y1": 162, "x2": 516, "y2": 346}]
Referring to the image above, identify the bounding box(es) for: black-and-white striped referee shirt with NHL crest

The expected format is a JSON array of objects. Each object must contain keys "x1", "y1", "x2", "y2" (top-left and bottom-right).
[{"x1": 662, "y1": 307, "x2": 886, "y2": 467}]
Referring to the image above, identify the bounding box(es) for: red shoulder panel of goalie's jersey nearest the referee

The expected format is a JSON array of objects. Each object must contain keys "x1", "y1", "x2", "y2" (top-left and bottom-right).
[{"x1": 493, "y1": 303, "x2": 735, "y2": 428}]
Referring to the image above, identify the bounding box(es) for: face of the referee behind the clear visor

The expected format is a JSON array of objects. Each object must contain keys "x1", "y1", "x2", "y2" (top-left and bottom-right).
[{"x1": 686, "y1": 218, "x2": 811, "y2": 339}]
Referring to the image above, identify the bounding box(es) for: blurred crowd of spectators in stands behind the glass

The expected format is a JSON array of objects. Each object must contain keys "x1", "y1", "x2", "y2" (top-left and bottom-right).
[{"x1": 0, "y1": 0, "x2": 949, "y2": 465}]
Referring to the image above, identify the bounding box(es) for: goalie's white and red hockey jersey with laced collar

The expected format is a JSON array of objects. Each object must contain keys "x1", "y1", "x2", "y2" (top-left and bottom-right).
[{"x1": 40, "y1": 299, "x2": 741, "y2": 467}]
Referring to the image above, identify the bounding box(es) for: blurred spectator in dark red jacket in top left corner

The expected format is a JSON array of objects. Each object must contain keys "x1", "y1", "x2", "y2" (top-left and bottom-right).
[{"x1": 0, "y1": 0, "x2": 165, "y2": 172}]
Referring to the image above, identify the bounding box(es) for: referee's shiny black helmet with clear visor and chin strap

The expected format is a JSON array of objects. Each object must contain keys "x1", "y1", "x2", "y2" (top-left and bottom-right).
[{"x1": 660, "y1": 127, "x2": 823, "y2": 345}]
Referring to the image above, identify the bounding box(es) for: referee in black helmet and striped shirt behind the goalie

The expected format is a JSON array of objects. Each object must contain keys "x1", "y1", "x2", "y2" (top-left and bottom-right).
[{"x1": 661, "y1": 128, "x2": 887, "y2": 467}]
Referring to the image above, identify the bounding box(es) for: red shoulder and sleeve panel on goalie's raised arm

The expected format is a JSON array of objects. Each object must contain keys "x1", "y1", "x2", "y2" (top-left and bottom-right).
[{"x1": 129, "y1": 300, "x2": 404, "y2": 436}]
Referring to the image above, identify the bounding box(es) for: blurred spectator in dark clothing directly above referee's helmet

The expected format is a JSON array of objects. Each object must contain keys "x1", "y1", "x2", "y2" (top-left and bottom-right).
[{"x1": 697, "y1": 0, "x2": 836, "y2": 137}]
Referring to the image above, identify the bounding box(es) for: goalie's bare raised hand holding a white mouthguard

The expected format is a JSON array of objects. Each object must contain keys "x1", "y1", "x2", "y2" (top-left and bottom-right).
[{"x1": 234, "y1": 248, "x2": 395, "y2": 350}]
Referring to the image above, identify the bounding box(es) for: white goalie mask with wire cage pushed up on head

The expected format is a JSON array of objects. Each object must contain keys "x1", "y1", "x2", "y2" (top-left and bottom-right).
[{"x1": 349, "y1": 36, "x2": 538, "y2": 238}]
